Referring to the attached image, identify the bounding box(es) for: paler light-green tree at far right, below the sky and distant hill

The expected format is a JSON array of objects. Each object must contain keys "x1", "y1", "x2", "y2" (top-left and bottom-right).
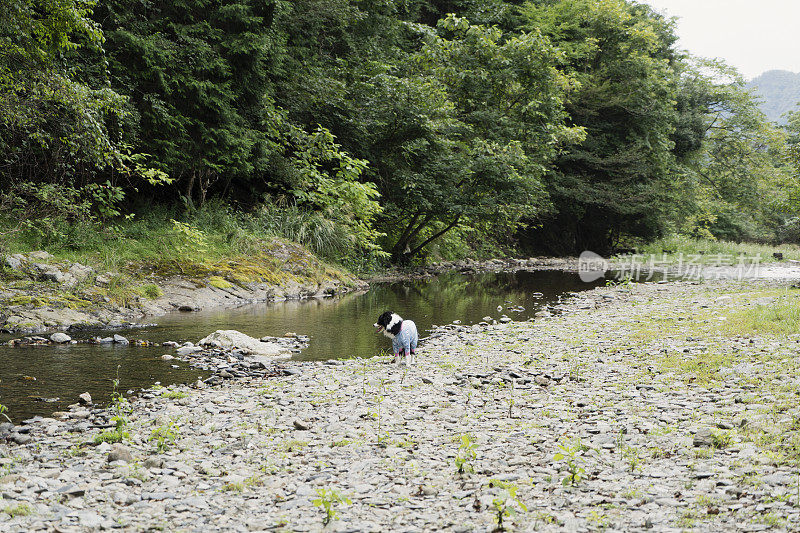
[{"x1": 676, "y1": 59, "x2": 791, "y2": 241}]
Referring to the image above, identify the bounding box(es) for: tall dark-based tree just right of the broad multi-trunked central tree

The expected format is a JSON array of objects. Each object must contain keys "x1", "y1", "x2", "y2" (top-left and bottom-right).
[{"x1": 521, "y1": 0, "x2": 678, "y2": 254}]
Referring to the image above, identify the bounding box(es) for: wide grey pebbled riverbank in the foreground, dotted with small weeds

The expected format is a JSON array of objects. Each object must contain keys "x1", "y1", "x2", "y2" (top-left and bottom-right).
[{"x1": 0, "y1": 282, "x2": 800, "y2": 531}]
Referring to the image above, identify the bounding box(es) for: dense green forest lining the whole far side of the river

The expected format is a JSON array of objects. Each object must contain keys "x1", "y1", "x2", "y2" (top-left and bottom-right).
[{"x1": 0, "y1": 0, "x2": 800, "y2": 269}]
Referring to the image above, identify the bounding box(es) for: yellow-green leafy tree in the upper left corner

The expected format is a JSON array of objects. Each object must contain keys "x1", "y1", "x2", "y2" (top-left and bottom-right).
[{"x1": 0, "y1": 0, "x2": 123, "y2": 191}]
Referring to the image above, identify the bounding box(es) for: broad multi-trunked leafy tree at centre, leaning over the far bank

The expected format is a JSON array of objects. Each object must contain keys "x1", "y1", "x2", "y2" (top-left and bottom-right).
[{"x1": 356, "y1": 15, "x2": 580, "y2": 262}]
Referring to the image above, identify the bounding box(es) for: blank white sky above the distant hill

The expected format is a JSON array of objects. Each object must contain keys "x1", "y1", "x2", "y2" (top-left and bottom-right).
[{"x1": 639, "y1": 0, "x2": 800, "y2": 79}]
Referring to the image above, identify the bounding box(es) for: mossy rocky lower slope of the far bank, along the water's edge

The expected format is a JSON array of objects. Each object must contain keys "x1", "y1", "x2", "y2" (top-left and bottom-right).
[{"x1": 0, "y1": 241, "x2": 368, "y2": 334}]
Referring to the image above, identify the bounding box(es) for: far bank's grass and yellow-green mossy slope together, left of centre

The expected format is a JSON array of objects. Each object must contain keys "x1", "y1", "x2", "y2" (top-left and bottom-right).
[{"x1": 0, "y1": 205, "x2": 366, "y2": 316}]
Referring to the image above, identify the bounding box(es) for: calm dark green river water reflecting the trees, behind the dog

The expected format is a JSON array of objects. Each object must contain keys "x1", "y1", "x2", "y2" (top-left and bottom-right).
[{"x1": 0, "y1": 271, "x2": 603, "y2": 422}]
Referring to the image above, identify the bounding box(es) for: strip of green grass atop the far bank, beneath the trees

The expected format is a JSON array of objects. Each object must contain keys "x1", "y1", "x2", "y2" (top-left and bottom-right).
[{"x1": 0, "y1": 203, "x2": 374, "y2": 271}]
